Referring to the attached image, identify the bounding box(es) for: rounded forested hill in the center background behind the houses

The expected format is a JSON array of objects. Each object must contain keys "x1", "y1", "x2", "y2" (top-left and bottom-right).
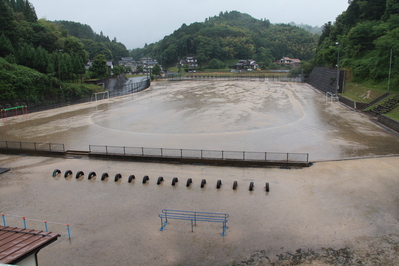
[{"x1": 131, "y1": 11, "x2": 319, "y2": 66}]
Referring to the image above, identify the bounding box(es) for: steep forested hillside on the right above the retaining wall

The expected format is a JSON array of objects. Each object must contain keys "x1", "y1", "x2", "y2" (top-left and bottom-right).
[{"x1": 315, "y1": 0, "x2": 399, "y2": 90}]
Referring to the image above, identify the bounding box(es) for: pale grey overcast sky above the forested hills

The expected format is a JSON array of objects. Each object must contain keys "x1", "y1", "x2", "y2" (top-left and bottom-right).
[{"x1": 30, "y1": 0, "x2": 348, "y2": 50}]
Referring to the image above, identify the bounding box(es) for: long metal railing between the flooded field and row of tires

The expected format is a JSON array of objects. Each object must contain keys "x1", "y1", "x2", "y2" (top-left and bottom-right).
[{"x1": 89, "y1": 145, "x2": 309, "y2": 163}]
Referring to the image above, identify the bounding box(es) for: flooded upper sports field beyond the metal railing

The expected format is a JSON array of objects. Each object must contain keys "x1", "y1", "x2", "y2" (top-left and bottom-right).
[{"x1": 0, "y1": 81, "x2": 399, "y2": 161}]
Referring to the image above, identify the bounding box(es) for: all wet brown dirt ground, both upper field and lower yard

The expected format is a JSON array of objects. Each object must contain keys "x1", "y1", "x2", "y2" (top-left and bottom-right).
[{"x1": 0, "y1": 82, "x2": 399, "y2": 265}]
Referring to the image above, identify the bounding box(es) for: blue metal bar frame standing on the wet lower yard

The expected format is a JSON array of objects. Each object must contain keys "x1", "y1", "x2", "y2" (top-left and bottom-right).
[{"x1": 158, "y1": 209, "x2": 229, "y2": 236}]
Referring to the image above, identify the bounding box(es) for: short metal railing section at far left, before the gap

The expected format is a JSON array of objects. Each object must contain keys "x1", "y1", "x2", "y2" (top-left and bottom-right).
[{"x1": 0, "y1": 141, "x2": 65, "y2": 152}]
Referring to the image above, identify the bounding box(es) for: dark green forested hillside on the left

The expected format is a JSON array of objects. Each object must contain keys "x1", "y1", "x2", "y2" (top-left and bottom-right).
[{"x1": 0, "y1": 0, "x2": 128, "y2": 102}]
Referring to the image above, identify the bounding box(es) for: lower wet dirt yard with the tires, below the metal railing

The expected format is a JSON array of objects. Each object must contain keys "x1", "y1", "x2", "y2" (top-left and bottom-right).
[{"x1": 0, "y1": 155, "x2": 399, "y2": 265}]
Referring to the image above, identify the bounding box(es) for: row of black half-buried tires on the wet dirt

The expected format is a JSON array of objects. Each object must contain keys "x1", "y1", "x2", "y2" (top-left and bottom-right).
[{"x1": 53, "y1": 169, "x2": 270, "y2": 192}]
